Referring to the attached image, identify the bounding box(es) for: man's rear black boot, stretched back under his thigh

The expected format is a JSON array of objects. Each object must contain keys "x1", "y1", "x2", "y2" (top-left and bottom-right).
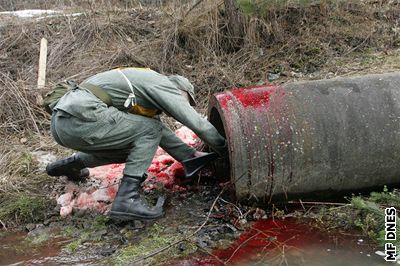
[{"x1": 46, "y1": 154, "x2": 89, "y2": 182}]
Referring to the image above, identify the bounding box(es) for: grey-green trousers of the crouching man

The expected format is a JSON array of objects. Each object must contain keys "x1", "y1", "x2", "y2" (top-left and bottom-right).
[{"x1": 51, "y1": 89, "x2": 164, "y2": 176}]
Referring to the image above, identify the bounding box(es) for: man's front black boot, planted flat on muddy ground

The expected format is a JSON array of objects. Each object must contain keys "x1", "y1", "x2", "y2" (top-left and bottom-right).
[{"x1": 109, "y1": 175, "x2": 164, "y2": 221}]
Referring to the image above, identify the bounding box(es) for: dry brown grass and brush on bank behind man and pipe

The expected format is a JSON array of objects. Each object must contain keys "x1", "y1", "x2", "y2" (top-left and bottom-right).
[{"x1": 0, "y1": 0, "x2": 400, "y2": 231}]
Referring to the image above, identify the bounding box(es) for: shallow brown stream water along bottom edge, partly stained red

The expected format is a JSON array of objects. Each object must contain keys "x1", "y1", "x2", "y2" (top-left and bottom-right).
[{"x1": 0, "y1": 219, "x2": 387, "y2": 266}]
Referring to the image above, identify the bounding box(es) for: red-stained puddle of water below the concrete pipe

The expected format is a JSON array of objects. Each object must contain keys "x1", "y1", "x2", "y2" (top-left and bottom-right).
[{"x1": 171, "y1": 219, "x2": 384, "y2": 265}]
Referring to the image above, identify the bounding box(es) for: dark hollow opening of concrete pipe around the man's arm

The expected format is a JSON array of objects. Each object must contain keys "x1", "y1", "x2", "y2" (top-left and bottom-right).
[{"x1": 210, "y1": 107, "x2": 231, "y2": 181}]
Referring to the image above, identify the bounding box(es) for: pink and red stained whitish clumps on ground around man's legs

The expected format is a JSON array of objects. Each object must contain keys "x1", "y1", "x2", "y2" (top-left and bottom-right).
[{"x1": 57, "y1": 127, "x2": 199, "y2": 217}]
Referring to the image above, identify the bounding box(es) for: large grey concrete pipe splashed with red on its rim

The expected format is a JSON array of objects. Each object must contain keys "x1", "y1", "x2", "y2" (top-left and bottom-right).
[{"x1": 208, "y1": 73, "x2": 400, "y2": 201}]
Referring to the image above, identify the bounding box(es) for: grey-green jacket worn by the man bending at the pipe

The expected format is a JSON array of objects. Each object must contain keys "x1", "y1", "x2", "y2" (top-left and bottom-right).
[{"x1": 57, "y1": 68, "x2": 226, "y2": 161}]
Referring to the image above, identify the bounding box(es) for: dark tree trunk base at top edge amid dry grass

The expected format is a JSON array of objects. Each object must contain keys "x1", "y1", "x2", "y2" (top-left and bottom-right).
[{"x1": 224, "y1": 0, "x2": 244, "y2": 47}]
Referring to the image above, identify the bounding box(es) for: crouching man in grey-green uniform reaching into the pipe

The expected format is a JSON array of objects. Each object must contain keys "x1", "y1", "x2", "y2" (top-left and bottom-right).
[{"x1": 46, "y1": 68, "x2": 227, "y2": 220}]
